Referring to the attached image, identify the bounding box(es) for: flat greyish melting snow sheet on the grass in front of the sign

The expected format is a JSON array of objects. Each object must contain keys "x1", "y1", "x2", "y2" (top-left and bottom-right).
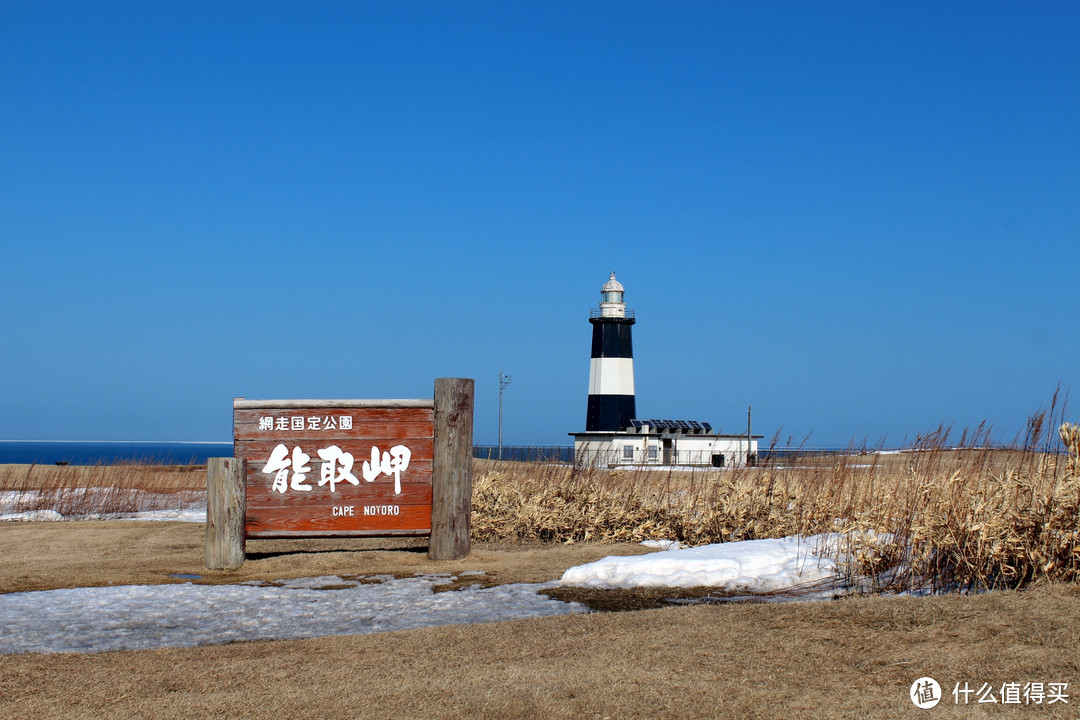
[{"x1": 0, "y1": 575, "x2": 586, "y2": 654}]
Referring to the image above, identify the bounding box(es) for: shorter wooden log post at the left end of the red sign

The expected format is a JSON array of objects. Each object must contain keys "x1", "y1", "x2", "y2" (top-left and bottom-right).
[{"x1": 206, "y1": 458, "x2": 247, "y2": 570}]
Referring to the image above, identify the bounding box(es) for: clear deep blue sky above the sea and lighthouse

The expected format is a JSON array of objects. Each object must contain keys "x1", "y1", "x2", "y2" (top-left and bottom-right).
[{"x1": 0, "y1": 2, "x2": 1080, "y2": 446}]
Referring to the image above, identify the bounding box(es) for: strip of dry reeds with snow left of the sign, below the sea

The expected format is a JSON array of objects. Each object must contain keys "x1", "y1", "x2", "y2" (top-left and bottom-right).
[{"x1": 0, "y1": 462, "x2": 206, "y2": 518}]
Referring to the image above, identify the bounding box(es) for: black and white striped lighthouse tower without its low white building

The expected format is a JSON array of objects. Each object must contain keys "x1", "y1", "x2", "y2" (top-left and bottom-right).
[{"x1": 585, "y1": 272, "x2": 636, "y2": 432}]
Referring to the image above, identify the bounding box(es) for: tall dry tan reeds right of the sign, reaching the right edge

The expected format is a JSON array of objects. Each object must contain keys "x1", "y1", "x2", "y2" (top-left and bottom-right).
[{"x1": 473, "y1": 421, "x2": 1080, "y2": 589}]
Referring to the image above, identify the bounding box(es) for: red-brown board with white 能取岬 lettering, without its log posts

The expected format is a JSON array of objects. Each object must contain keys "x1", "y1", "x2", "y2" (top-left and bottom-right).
[{"x1": 232, "y1": 398, "x2": 434, "y2": 538}]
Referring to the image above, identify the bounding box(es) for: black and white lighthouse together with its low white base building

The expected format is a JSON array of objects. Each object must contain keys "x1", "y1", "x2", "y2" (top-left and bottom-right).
[{"x1": 570, "y1": 273, "x2": 761, "y2": 467}]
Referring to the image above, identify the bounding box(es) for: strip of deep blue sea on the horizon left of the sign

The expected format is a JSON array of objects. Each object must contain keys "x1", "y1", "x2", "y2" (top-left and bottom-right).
[{"x1": 0, "y1": 440, "x2": 232, "y2": 465}]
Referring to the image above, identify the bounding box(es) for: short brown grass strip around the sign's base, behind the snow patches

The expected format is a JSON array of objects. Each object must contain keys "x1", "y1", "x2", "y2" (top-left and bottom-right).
[{"x1": 0, "y1": 520, "x2": 648, "y2": 593}]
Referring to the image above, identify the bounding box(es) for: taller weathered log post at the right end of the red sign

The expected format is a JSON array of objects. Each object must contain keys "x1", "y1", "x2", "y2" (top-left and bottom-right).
[{"x1": 428, "y1": 378, "x2": 474, "y2": 560}]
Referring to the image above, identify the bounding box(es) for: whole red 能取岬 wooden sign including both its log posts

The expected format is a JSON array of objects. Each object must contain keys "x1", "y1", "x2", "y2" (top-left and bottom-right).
[{"x1": 206, "y1": 378, "x2": 475, "y2": 570}]
